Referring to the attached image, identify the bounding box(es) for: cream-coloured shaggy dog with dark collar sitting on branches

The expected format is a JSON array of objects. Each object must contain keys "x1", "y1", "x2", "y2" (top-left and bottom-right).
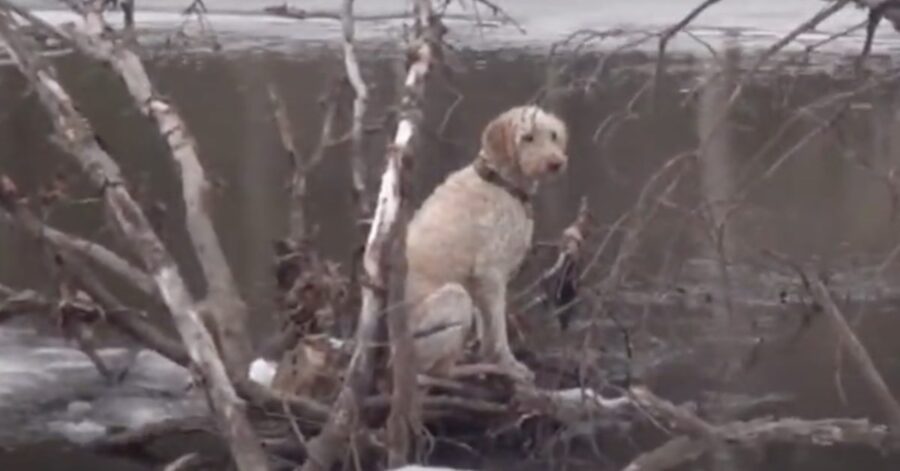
[{"x1": 405, "y1": 106, "x2": 568, "y2": 382}]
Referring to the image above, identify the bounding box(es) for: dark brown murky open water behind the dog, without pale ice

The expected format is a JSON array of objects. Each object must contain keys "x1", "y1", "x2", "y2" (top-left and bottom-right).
[{"x1": 0, "y1": 23, "x2": 900, "y2": 471}]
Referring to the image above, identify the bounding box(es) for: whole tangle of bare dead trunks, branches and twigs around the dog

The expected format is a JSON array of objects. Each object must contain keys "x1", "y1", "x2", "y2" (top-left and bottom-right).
[{"x1": 0, "y1": 0, "x2": 900, "y2": 471}]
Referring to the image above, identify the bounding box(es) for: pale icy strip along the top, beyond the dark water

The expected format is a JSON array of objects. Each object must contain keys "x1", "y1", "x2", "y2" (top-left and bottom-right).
[{"x1": 19, "y1": 0, "x2": 897, "y2": 51}]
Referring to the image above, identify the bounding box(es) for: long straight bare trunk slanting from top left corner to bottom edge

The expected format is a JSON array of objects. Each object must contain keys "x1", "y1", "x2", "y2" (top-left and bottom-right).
[{"x1": 0, "y1": 8, "x2": 268, "y2": 470}]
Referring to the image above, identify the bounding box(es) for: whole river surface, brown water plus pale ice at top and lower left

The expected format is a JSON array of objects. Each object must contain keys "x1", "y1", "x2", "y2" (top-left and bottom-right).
[{"x1": 0, "y1": 0, "x2": 900, "y2": 471}]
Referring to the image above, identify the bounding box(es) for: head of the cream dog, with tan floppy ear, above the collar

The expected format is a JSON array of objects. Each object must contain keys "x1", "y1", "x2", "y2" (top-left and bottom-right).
[{"x1": 481, "y1": 106, "x2": 569, "y2": 180}]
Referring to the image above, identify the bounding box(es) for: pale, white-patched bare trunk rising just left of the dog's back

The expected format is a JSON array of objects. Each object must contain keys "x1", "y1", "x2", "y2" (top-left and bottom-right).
[{"x1": 303, "y1": 0, "x2": 440, "y2": 471}]
